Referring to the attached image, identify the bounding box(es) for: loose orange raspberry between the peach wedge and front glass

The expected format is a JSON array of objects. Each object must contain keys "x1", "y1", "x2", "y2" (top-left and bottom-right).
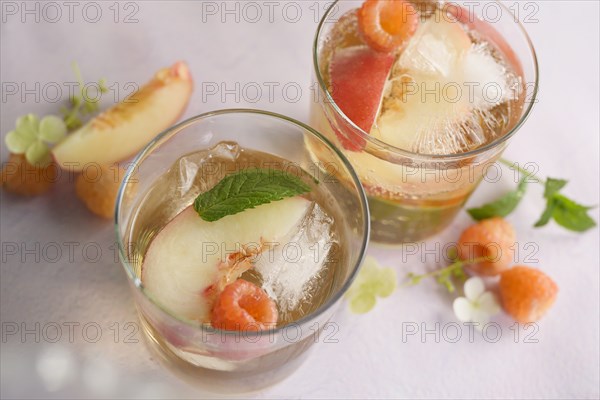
[{"x1": 75, "y1": 165, "x2": 125, "y2": 218}]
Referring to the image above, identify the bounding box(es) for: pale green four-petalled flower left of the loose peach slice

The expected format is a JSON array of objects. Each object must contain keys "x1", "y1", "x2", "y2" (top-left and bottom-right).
[{"x1": 4, "y1": 114, "x2": 67, "y2": 167}]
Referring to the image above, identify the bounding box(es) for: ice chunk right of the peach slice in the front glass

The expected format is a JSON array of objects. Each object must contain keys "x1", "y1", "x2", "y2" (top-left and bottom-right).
[{"x1": 255, "y1": 203, "x2": 333, "y2": 319}]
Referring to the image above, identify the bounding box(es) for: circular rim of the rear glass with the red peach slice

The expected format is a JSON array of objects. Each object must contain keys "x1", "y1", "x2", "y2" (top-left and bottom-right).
[{"x1": 313, "y1": 0, "x2": 539, "y2": 161}]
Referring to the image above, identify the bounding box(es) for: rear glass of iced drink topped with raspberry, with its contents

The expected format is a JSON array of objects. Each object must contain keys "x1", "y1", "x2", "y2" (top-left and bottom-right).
[{"x1": 311, "y1": 0, "x2": 537, "y2": 244}]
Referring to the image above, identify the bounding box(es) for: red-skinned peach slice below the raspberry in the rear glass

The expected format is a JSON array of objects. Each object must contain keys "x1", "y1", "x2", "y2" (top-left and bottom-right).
[{"x1": 329, "y1": 46, "x2": 394, "y2": 151}]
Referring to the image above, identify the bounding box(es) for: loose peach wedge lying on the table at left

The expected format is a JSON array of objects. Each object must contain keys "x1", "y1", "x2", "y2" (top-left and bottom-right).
[{"x1": 52, "y1": 62, "x2": 193, "y2": 171}]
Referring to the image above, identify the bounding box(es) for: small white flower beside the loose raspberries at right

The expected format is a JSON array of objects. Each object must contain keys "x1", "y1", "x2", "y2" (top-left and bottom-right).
[{"x1": 452, "y1": 277, "x2": 500, "y2": 330}]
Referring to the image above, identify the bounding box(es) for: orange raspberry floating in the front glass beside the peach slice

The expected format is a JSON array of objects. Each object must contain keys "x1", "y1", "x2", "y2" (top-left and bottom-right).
[{"x1": 210, "y1": 279, "x2": 278, "y2": 331}]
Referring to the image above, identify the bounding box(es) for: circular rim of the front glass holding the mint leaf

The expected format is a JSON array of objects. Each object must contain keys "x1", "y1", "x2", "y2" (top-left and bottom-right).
[{"x1": 114, "y1": 108, "x2": 371, "y2": 337}]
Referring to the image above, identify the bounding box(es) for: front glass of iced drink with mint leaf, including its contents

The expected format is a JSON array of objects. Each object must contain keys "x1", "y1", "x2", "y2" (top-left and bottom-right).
[{"x1": 116, "y1": 110, "x2": 369, "y2": 391}]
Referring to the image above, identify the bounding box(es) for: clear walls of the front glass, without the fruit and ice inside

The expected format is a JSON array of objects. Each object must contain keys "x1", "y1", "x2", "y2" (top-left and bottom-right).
[{"x1": 115, "y1": 109, "x2": 369, "y2": 392}]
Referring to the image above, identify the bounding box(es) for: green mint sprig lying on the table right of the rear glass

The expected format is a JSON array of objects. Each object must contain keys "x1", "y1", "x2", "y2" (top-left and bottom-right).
[{"x1": 467, "y1": 159, "x2": 596, "y2": 232}]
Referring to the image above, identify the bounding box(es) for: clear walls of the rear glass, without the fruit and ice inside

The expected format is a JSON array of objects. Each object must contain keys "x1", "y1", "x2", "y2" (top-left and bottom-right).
[{"x1": 310, "y1": 1, "x2": 538, "y2": 245}]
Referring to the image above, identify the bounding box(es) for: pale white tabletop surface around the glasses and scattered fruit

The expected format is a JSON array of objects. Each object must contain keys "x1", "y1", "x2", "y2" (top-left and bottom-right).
[{"x1": 0, "y1": 1, "x2": 600, "y2": 398}]
